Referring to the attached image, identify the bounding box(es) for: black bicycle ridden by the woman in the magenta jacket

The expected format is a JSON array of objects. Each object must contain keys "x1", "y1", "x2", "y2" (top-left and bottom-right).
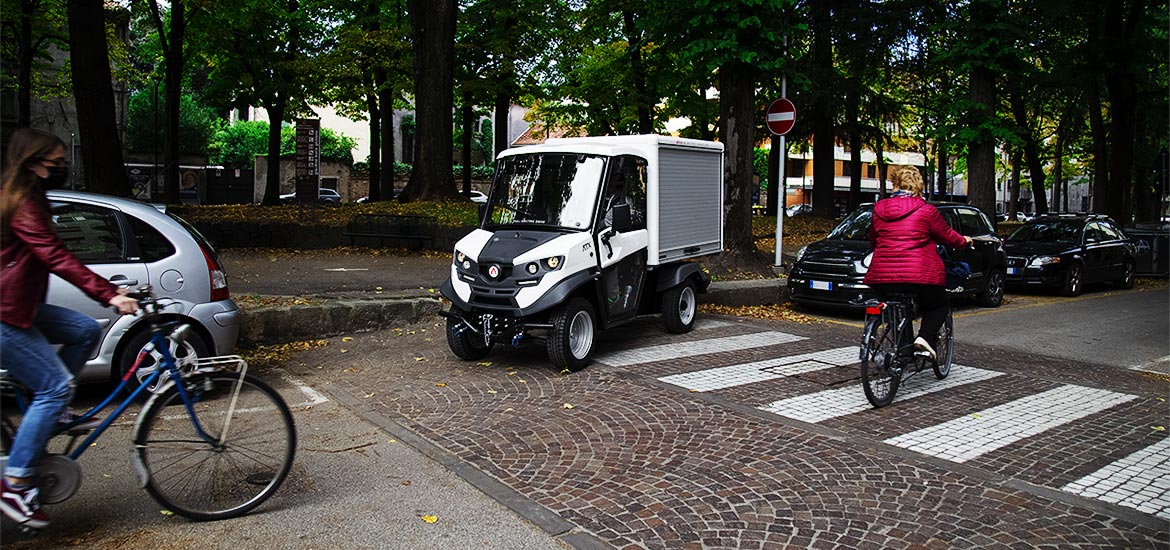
[{"x1": 861, "y1": 289, "x2": 962, "y2": 408}]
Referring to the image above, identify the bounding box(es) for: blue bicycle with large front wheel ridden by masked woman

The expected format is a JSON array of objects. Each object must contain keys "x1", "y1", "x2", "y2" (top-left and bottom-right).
[{"x1": 0, "y1": 286, "x2": 296, "y2": 528}]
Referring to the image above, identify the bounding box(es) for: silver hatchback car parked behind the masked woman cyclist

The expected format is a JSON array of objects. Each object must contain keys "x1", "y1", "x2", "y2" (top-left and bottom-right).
[{"x1": 47, "y1": 191, "x2": 240, "y2": 391}]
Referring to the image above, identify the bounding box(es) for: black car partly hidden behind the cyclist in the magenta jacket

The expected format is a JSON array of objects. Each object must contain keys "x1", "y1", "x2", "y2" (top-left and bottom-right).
[{"x1": 789, "y1": 202, "x2": 1007, "y2": 309}]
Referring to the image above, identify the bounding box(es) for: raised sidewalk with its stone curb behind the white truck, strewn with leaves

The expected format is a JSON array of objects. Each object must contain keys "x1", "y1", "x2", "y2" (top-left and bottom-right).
[{"x1": 220, "y1": 249, "x2": 784, "y2": 346}]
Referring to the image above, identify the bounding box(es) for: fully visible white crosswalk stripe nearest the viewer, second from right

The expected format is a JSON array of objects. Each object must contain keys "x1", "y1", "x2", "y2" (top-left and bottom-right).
[{"x1": 886, "y1": 386, "x2": 1137, "y2": 462}]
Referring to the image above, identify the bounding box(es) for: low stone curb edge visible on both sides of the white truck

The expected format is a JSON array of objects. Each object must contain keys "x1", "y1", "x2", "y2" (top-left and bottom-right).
[{"x1": 236, "y1": 279, "x2": 787, "y2": 348}]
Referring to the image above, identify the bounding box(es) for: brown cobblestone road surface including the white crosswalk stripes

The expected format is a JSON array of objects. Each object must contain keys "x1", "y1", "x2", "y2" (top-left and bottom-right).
[{"x1": 289, "y1": 316, "x2": 1170, "y2": 549}]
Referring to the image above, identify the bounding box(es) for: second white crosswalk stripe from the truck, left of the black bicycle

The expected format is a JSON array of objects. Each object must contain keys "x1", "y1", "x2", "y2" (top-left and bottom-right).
[{"x1": 659, "y1": 345, "x2": 858, "y2": 392}]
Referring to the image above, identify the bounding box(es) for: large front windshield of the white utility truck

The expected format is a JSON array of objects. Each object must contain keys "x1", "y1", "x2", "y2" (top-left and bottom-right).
[{"x1": 487, "y1": 153, "x2": 605, "y2": 231}]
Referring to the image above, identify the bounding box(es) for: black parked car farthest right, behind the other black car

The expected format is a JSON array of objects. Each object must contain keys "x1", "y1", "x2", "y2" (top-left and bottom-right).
[{"x1": 1004, "y1": 214, "x2": 1136, "y2": 296}]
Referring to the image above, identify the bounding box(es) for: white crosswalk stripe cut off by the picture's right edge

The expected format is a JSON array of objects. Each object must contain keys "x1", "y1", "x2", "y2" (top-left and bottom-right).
[{"x1": 1061, "y1": 439, "x2": 1170, "y2": 520}]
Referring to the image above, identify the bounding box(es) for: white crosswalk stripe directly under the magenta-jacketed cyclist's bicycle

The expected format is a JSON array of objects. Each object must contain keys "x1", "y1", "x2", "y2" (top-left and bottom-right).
[{"x1": 759, "y1": 365, "x2": 1003, "y2": 424}]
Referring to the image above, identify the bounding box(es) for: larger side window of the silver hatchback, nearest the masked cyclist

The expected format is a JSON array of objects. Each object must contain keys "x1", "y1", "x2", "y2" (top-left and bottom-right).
[{"x1": 49, "y1": 202, "x2": 125, "y2": 263}]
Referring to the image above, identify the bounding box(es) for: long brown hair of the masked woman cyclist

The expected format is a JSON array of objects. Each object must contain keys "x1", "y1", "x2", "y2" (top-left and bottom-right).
[{"x1": 0, "y1": 128, "x2": 64, "y2": 245}]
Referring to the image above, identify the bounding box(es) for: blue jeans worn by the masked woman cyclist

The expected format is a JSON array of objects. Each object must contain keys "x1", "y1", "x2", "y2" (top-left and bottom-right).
[{"x1": 0, "y1": 303, "x2": 102, "y2": 477}]
